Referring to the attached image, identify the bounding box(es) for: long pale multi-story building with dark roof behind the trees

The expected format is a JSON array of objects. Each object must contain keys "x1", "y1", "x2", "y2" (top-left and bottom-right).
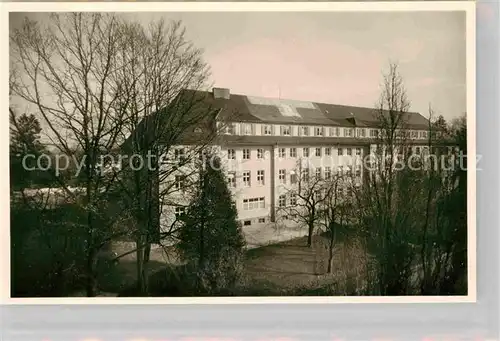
[{"x1": 156, "y1": 88, "x2": 446, "y2": 239}]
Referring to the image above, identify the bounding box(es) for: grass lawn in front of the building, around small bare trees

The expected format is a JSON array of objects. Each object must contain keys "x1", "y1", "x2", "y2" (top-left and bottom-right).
[{"x1": 95, "y1": 235, "x2": 363, "y2": 296}]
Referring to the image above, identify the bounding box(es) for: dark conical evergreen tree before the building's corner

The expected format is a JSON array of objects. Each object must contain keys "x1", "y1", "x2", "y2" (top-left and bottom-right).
[{"x1": 178, "y1": 156, "x2": 245, "y2": 294}]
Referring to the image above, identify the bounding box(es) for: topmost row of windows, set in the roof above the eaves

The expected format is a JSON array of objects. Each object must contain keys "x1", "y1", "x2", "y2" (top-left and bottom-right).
[{"x1": 223, "y1": 123, "x2": 427, "y2": 139}]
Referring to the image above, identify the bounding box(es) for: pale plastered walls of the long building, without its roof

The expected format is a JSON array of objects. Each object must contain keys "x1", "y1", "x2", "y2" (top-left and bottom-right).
[{"x1": 160, "y1": 123, "x2": 444, "y2": 244}]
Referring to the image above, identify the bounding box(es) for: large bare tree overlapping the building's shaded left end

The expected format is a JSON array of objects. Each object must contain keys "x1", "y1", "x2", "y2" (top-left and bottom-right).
[{"x1": 109, "y1": 20, "x2": 223, "y2": 294}]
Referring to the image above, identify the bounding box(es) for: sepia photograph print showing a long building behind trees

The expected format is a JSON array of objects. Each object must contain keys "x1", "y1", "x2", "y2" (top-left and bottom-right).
[{"x1": 5, "y1": 3, "x2": 477, "y2": 302}]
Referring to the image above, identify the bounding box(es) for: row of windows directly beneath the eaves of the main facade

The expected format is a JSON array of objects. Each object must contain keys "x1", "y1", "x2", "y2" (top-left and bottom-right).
[{"x1": 227, "y1": 147, "x2": 362, "y2": 160}]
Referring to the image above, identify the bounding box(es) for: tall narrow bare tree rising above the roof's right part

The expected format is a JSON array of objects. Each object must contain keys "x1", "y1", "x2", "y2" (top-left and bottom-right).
[{"x1": 358, "y1": 64, "x2": 414, "y2": 295}]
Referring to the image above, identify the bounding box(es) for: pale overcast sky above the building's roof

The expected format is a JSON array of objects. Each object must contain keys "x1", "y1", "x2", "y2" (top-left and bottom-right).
[{"x1": 9, "y1": 12, "x2": 466, "y2": 119}]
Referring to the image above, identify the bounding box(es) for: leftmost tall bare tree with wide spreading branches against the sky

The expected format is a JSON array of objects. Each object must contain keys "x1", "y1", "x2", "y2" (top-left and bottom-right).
[{"x1": 11, "y1": 13, "x2": 141, "y2": 296}]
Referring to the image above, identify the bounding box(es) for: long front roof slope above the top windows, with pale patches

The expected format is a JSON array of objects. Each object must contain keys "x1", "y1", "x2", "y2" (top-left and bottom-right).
[{"x1": 185, "y1": 90, "x2": 428, "y2": 129}]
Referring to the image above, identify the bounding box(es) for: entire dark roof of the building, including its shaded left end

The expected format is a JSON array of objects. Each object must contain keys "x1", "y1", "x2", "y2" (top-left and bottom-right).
[{"x1": 128, "y1": 90, "x2": 434, "y2": 147}]
